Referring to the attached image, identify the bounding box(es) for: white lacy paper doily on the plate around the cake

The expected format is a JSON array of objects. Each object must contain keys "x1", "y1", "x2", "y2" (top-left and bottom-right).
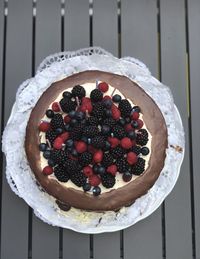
[{"x1": 3, "y1": 47, "x2": 184, "y2": 233}]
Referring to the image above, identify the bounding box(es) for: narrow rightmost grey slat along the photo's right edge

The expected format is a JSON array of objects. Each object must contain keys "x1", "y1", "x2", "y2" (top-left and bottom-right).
[{"x1": 188, "y1": 0, "x2": 200, "y2": 258}]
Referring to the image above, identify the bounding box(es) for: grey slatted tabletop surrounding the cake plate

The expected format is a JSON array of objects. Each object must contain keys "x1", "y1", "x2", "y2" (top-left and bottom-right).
[{"x1": 0, "y1": 0, "x2": 200, "y2": 259}]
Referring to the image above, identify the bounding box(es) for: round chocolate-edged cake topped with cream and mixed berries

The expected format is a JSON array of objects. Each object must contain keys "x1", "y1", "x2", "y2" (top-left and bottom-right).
[{"x1": 25, "y1": 71, "x2": 167, "y2": 211}]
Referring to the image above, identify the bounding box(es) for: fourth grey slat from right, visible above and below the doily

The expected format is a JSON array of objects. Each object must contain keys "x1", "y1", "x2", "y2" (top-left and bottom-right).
[{"x1": 93, "y1": 0, "x2": 120, "y2": 259}]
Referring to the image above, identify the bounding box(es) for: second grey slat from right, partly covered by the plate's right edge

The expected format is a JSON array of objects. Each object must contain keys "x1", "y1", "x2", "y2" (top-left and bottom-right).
[{"x1": 160, "y1": 0, "x2": 192, "y2": 259}]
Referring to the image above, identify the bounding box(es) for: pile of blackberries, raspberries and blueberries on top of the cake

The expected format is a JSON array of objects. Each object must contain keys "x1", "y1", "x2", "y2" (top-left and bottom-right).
[{"x1": 39, "y1": 82, "x2": 149, "y2": 196}]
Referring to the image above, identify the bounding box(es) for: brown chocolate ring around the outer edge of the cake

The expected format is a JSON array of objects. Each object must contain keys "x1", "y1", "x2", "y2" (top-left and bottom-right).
[{"x1": 25, "y1": 71, "x2": 167, "y2": 211}]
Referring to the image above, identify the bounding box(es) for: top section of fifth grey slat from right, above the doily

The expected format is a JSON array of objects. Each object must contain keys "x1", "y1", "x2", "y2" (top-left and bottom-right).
[{"x1": 64, "y1": 0, "x2": 89, "y2": 50}]
